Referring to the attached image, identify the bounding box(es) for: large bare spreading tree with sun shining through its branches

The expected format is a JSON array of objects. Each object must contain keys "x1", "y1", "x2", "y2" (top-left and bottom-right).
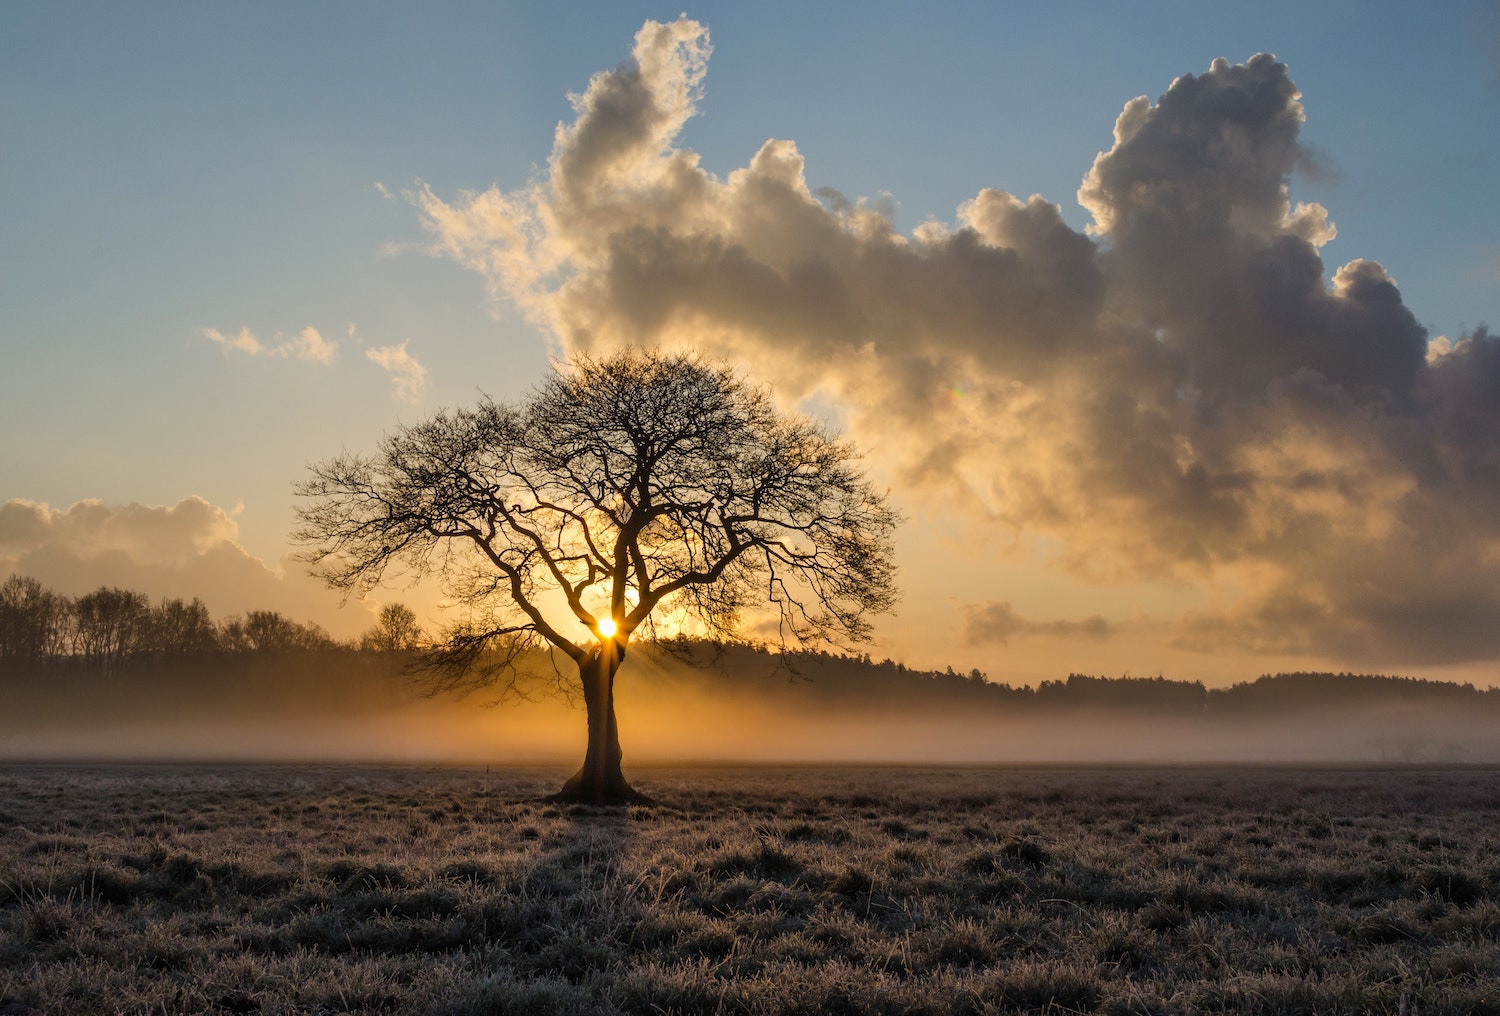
[{"x1": 296, "y1": 350, "x2": 897, "y2": 803}]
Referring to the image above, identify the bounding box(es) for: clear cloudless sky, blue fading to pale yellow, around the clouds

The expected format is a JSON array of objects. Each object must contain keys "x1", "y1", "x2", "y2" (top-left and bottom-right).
[{"x1": 0, "y1": 3, "x2": 1500, "y2": 684}]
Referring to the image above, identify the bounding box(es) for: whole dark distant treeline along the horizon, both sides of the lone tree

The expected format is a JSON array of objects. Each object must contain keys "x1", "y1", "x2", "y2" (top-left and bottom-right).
[{"x1": 0, "y1": 575, "x2": 1500, "y2": 717}]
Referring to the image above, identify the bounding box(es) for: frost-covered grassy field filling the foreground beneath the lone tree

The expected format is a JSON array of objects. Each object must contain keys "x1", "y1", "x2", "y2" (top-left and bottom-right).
[{"x1": 0, "y1": 765, "x2": 1500, "y2": 1016}]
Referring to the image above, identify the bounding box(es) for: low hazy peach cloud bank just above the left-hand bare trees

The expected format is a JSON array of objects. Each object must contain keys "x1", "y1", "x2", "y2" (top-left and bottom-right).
[{"x1": 0, "y1": 495, "x2": 369, "y2": 635}]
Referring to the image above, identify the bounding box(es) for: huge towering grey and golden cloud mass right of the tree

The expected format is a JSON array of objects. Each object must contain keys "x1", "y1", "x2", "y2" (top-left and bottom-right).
[{"x1": 411, "y1": 18, "x2": 1500, "y2": 663}]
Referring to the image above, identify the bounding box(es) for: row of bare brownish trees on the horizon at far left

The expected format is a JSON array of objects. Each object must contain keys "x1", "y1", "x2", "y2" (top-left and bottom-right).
[{"x1": 0, "y1": 575, "x2": 423, "y2": 672}]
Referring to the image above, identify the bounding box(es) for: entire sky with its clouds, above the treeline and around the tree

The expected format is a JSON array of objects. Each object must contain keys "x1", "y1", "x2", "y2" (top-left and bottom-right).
[{"x1": 0, "y1": 2, "x2": 1500, "y2": 686}]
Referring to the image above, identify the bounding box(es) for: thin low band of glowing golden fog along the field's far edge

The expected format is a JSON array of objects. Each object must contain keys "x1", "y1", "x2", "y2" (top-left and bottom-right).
[{"x1": 0, "y1": 704, "x2": 1500, "y2": 768}]
